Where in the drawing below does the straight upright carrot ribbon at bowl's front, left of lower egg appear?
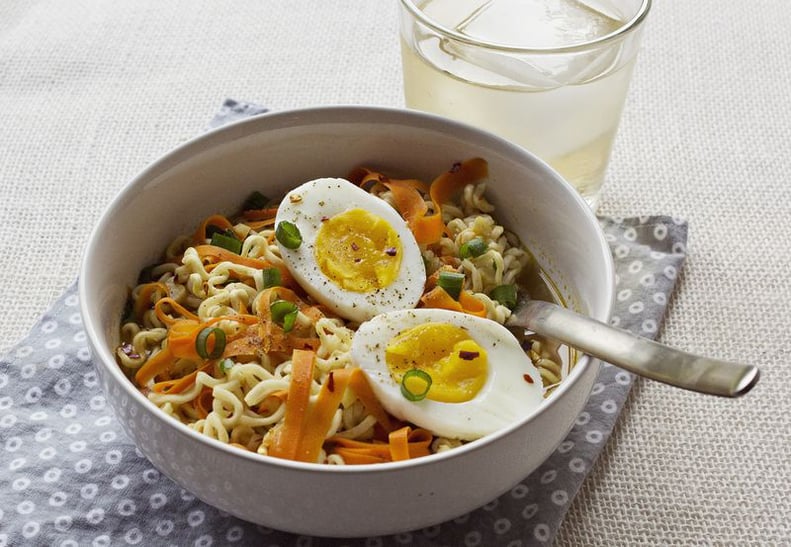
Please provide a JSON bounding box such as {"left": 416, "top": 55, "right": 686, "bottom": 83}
{"left": 269, "top": 349, "right": 316, "bottom": 460}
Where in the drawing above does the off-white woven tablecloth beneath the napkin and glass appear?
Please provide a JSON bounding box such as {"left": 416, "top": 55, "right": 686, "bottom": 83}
{"left": 0, "top": 0, "right": 791, "bottom": 545}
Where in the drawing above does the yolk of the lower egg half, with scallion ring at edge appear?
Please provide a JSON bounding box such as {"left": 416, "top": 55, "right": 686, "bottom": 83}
{"left": 385, "top": 323, "right": 489, "bottom": 403}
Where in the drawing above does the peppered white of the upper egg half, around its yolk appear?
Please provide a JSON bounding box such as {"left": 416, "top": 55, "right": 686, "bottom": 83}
{"left": 275, "top": 178, "right": 426, "bottom": 322}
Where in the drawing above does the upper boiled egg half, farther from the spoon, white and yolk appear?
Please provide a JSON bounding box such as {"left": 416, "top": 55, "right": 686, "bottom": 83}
{"left": 275, "top": 178, "right": 426, "bottom": 322}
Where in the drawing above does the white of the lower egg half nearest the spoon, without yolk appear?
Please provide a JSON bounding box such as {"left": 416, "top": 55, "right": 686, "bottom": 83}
{"left": 351, "top": 308, "right": 543, "bottom": 440}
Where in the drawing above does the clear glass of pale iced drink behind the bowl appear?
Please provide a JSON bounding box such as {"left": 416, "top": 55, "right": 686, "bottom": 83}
{"left": 400, "top": 0, "right": 651, "bottom": 210}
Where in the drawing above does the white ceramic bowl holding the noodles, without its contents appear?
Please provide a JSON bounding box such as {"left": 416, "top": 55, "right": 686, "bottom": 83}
{"left": 79, "top": 107, "right": 614, "bottom": 537}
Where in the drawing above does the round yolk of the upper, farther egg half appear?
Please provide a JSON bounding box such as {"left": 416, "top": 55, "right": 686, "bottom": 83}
{"left": 315, "top": 209, "right": 402, "bottom": 293}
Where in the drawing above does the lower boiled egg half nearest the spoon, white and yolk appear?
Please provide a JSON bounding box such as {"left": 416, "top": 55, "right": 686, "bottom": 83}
{"left": 351, "top": 308, "right": 543, "bottom": 440}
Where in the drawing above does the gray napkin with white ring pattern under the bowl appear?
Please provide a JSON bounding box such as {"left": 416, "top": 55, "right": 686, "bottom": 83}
{"left": 0, "top": 101, "right": 687, "bottom": 547}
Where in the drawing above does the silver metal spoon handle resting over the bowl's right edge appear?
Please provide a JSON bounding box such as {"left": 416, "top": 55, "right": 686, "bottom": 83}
{"left": 506, "top": 300, "right": 759, "bottom": 397}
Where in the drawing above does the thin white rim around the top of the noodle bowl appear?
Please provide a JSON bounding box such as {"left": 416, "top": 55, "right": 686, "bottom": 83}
{"left": 78, "top": 105, "right": 615, "bottom": 474}
